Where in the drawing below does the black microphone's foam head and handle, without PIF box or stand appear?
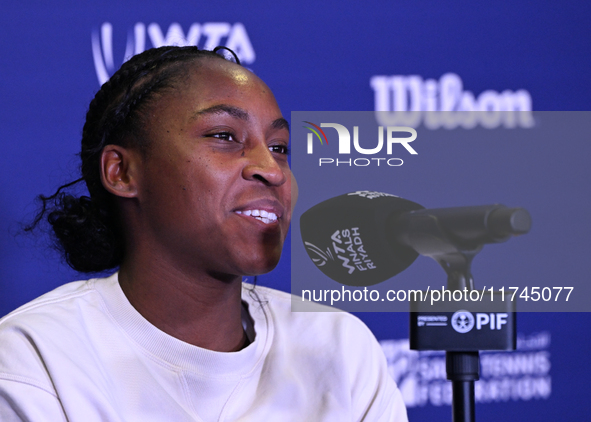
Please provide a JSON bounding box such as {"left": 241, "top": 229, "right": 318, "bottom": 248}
{"left": 300, "top": 191, "right": 531, "bottom": 286}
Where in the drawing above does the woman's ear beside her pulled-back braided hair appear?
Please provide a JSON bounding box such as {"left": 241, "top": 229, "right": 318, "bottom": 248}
{"left": 101, "top": 145, "right": 140, "bottom": 198}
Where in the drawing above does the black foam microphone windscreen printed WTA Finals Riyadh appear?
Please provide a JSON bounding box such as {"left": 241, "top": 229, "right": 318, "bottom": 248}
{"left": 300, "top": 191, "right": 423, "bottom": 286}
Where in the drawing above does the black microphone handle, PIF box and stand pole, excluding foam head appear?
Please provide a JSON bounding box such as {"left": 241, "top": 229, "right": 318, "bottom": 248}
{"left": 395, "top": 205, "right": 531, "bottom": 422}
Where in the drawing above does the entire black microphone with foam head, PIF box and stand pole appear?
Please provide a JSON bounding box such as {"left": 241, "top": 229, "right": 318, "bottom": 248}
{"left": 300, "top": 195, "right": 531, "bottom": 422}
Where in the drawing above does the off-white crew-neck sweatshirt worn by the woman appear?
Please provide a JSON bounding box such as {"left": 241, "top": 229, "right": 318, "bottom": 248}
{"left": 0, "top": 274, "right": 407, "bottom": 422}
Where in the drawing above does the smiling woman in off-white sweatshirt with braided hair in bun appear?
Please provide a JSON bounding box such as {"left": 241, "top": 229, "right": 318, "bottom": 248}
{"left": 0, "top": 47, "right": 406, "bottom": 422}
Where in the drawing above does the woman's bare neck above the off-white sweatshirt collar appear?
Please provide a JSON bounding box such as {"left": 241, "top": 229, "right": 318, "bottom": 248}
{"left": 119, "top": 259, "right": 246, "bottom": 352}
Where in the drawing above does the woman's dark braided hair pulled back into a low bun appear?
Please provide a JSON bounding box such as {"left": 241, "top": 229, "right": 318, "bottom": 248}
{"left": 25, "top": 46, "right": 240, "bottom": 273}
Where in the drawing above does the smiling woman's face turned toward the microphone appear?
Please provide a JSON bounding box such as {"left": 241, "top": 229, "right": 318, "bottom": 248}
{"left": 132, "top": 59, "right": 295, "bottom": 277}
